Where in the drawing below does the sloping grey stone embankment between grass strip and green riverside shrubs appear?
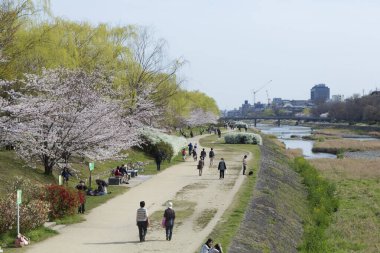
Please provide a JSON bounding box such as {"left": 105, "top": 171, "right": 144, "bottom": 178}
{"left": 229, "top": 139, "right": 307, "bottom": 253}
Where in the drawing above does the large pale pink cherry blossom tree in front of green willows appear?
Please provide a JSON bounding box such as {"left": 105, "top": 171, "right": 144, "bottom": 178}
{"left": 0, "top": 69, "right": 155, "bottom": 175}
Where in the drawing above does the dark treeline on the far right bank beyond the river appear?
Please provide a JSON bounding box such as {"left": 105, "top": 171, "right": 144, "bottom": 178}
{"left": 312, "top": 92, "right": 380, "bottom": 123}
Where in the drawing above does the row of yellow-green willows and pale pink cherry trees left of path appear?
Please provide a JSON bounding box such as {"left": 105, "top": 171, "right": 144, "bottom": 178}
{"left": 0, "top": 0, "right": 219, "bottom": 174}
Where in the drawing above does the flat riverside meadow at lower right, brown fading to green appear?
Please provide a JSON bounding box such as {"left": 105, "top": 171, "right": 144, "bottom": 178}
{"left": 311, "top": 158, "right": 380, "bottom": 253}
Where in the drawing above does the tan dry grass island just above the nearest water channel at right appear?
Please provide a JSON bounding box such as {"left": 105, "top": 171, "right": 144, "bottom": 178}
{"left": 313, "top": 139, "right": 380, "bottom": 154}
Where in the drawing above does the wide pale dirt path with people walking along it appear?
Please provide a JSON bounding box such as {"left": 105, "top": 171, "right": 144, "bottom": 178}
{"left": 26, "top": 137, "right": 250, "bottom": 253}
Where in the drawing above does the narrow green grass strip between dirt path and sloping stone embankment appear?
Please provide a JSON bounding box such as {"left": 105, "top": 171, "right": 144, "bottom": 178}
{"left": 197, "top": 135, "right": 260, "bottom": 251}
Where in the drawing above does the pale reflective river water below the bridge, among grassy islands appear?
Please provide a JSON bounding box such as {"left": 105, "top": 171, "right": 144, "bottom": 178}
{"left": 256, "top": 124, "right": 336, "bottom": 159}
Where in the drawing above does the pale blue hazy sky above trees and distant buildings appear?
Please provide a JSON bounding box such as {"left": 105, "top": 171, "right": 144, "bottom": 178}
{"left": 51, "top": 0, "right": 380, "bottom": 109}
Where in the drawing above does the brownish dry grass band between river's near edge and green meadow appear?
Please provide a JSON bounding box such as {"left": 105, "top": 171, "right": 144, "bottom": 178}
{"left": 310, "top": 158, "right": 380, "bottom": 180}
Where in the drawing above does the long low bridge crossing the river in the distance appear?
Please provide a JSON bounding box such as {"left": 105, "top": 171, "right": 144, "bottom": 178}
{"left": 219, "top": 116, "right": 331, "bottom": 126}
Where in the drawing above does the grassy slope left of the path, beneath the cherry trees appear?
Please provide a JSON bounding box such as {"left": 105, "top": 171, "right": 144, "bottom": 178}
{"left": 0, "top": 147, "right": 182, "bottom": 252}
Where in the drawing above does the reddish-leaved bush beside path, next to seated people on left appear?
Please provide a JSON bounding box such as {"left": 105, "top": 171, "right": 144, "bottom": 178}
{"left": 46, "top": 185, "right": 80, "bottom": 219}
